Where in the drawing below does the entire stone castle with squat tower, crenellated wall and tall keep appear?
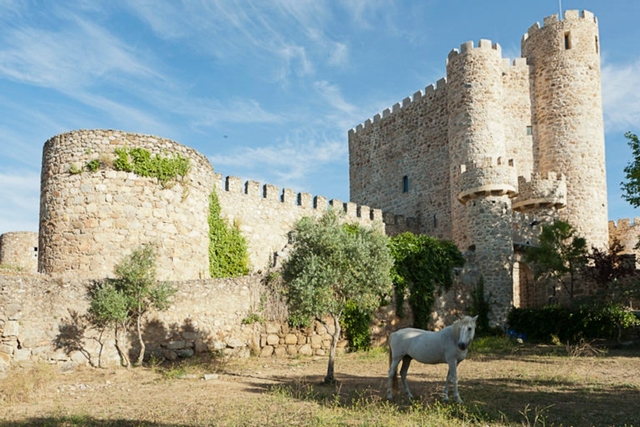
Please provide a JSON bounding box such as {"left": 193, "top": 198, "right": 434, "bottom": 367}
{"left": 0, "top": 10, "right": 636, "bottom": 330}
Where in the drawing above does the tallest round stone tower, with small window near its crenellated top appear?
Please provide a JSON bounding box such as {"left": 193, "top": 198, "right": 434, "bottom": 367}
{"left": 522, "top": 10, "right": 608, "bottom": 248}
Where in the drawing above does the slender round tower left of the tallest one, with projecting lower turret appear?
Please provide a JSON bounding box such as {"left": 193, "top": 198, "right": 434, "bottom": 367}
{"left": 447, "top": 40, "right": 517, "bottom": 324}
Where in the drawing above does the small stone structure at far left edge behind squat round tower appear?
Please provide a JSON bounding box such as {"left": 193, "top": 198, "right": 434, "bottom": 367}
{"left": 0, "top": 231, "right": 38, "bottom": 273}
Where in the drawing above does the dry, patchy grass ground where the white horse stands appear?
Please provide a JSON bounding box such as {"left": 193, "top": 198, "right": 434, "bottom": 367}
{"left": 0, "top": 347, "right": 640, "bottom": 427}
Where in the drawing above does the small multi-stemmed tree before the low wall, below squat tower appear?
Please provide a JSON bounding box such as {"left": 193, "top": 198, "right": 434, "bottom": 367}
{"left": 89, "top": 245, "right": 176, "bottom": 366}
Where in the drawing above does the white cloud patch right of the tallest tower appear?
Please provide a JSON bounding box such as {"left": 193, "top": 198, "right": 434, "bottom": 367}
{"left": 602, "top": 60, "right": 640, "bottom": 131}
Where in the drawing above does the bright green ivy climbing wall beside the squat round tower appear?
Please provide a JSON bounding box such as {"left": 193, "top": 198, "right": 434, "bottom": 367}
{"left": 209, "top": 191, "right": 249, "bottom": 278}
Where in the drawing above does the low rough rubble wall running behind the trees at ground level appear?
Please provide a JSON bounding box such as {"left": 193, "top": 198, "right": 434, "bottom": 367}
{"left": 0, "top": 274, "right": 411, "bottom": 373}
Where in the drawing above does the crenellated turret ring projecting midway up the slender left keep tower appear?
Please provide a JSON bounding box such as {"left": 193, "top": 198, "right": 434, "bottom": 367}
{"left": 453, "top": 157, "right": 518, "bottom": 204}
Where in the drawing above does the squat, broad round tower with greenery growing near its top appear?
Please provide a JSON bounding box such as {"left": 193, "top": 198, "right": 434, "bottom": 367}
{"left": 38, "top": 130, "right": 214, "bottom": 280}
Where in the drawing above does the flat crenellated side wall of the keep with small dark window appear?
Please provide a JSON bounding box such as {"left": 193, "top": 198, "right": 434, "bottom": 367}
{"left": 349, "top": 80, "right": 453, "bottom": 239}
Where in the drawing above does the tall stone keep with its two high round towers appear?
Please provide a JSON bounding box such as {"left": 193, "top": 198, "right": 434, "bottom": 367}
{"left": 349, "top": 10, "right": 608, "bottom": 322}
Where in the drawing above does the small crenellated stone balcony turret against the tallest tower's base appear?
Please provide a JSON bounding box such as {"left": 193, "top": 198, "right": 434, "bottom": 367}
{"left": 512, "top": 172, "right": 567, "bottom": 211}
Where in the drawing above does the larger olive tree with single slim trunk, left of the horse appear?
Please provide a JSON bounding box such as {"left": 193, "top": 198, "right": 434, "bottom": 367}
{"left": 282, "top": 210, "right": 393, "bottom": 382}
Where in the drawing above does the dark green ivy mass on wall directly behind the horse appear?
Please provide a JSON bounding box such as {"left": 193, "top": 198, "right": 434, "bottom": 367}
{"left": 390, "top": 232, "right": 464, "bottom": 329}
